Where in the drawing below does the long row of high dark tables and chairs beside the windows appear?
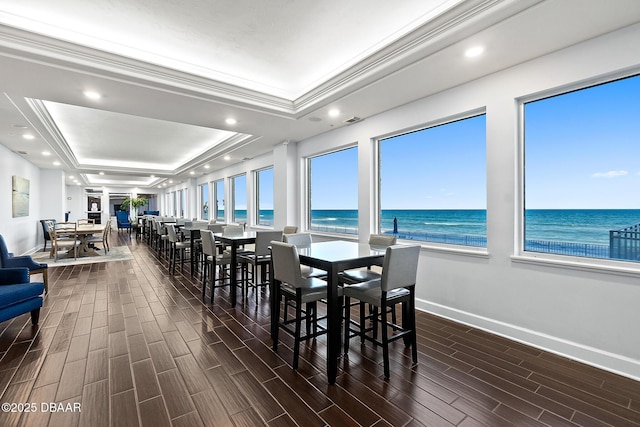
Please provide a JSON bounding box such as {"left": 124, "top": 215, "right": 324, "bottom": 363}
{"left": 135, "top": 216, "right": 420, "bottom": 384}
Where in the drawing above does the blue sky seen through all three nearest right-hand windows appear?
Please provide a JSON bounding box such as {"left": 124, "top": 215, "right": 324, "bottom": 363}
{"left": 311, "top": 76, "right": 640, "bottom": 213}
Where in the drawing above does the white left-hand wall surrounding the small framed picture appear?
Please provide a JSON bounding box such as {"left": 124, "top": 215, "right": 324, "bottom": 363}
{"left": 0, "top": 145, "right": 42, "bottom": 255}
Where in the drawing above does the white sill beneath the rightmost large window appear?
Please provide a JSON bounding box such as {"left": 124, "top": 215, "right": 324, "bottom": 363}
{"left": 511, "top": 253, "right": 640, "bottom": 277}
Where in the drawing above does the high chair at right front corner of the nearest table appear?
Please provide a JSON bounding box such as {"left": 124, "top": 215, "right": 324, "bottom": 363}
{"left": 343, "top": 245, "right": 420, "bottom": 378}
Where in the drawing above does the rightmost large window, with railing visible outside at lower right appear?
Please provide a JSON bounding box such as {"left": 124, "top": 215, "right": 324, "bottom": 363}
{"left": 523, "top": 75, "right": 640, "bottom": 262}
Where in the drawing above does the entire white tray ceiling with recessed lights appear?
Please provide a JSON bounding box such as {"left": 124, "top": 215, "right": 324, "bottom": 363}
{"left": 0, "top": 0, "right": 640, "bottom": 187}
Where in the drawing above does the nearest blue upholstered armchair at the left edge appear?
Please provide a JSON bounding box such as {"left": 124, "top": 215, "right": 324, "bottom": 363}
{"left": 0, "top": 268, "right": 44, "bottom": 325}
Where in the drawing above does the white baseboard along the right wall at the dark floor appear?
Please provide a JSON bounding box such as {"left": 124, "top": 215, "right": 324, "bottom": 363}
{"left": 416, "top": 299, "right": 640, "bottom": 381}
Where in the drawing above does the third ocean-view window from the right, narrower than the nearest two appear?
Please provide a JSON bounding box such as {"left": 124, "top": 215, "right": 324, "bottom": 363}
{"left": 308, "top": 147, "right": 358, "bottom": 234}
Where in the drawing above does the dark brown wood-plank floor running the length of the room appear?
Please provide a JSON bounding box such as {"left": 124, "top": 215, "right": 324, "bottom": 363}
{"left": 0, "top": 233, "right": 640, "bottom": 427}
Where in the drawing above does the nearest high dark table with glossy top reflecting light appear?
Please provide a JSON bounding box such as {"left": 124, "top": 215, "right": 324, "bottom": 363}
{"left": 270, "top": 240, "right": 386, "bottom": 384}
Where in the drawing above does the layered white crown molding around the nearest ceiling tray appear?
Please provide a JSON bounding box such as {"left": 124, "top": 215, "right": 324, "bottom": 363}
{"left": 0, "top": 0, "right": 542, "bottom": 119}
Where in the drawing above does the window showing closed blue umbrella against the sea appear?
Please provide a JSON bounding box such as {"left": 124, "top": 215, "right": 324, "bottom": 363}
{"left": 378, "top": 114, "right": 487, "bottom": 247}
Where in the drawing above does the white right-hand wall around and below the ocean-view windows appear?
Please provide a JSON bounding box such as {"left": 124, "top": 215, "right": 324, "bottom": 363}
{"left": 298, "top": 24, "right": 640, "bottom": 379}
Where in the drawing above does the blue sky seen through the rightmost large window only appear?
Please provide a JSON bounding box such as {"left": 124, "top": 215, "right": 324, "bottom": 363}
{"left": 525, "top": 76, "right": 640, "bottom": 209}
